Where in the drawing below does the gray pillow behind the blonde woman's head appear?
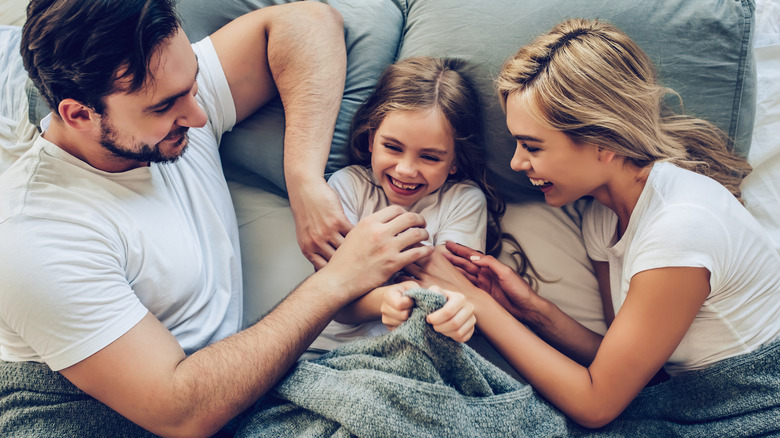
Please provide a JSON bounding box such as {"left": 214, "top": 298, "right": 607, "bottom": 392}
{"left": 399, "top": 0, "right": 756, "bottom": 201}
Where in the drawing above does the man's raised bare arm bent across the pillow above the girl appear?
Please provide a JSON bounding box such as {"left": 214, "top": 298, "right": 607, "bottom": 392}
{"left": 211, "top": 2, "right": 352, "bottom": 269}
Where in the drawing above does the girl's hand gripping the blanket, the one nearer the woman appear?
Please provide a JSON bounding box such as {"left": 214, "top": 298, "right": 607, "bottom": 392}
{"left": 425, "top": 286, "right": 477, "bottom": 342}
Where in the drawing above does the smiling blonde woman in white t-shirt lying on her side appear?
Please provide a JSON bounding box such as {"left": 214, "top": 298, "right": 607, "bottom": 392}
{"left": 402, "top": 19, "right": 780, "bottom": 436}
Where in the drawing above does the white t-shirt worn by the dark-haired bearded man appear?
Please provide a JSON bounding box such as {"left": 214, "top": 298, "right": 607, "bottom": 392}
{"left": 0, "top": 39, "right": 242, "bottom": 370}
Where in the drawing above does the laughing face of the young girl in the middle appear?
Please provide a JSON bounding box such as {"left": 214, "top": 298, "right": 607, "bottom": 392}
{"left": 368, "top": 109, "right": 456, "bottom": 207}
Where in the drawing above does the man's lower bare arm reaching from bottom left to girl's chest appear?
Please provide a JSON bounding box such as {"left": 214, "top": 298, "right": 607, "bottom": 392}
{"left": 61, "top": 206, "right": 431, "bottom": 436}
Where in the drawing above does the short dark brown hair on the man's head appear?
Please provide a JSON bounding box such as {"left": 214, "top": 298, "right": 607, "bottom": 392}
{"left": 21, "top": 0, "right": 179, "bottom": 114}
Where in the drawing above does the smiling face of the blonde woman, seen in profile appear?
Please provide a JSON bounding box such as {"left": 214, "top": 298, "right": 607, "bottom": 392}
{"left": 506, "top": 93, "right": 605, "bottom": 207}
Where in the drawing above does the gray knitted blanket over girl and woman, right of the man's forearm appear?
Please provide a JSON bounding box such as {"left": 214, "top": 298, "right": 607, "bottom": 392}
{"left": 237, "top": 290, "right": 780, "bottom": 437}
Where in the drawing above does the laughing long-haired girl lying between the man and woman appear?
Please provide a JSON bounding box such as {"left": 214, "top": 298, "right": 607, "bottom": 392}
{"left": 310, "top": 57, "right": 520, "bottom": 351}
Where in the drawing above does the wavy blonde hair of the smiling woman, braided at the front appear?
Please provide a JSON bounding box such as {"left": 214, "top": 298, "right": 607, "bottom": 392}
{"left": 497, "top": 19, "right": 751, "bottom": 199}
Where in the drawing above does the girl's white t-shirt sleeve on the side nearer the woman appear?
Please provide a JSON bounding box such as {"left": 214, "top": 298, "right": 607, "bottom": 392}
{"left": 434, "top": 184, "right": 487, "bottom": 252}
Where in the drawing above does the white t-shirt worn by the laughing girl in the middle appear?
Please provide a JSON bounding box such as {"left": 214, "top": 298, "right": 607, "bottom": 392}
{"left": 306, "top": 165, "right": 487, "bottom": 352}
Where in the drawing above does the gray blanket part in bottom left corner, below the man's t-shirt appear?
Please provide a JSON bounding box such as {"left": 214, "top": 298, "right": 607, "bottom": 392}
{"left": 0, "top": 362, "right": 155, "bottom": 438}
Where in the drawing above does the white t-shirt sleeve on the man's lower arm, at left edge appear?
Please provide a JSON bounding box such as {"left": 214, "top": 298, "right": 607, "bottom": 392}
{"left": 0, "top": 216, "right": 147, "bottom": 371}
